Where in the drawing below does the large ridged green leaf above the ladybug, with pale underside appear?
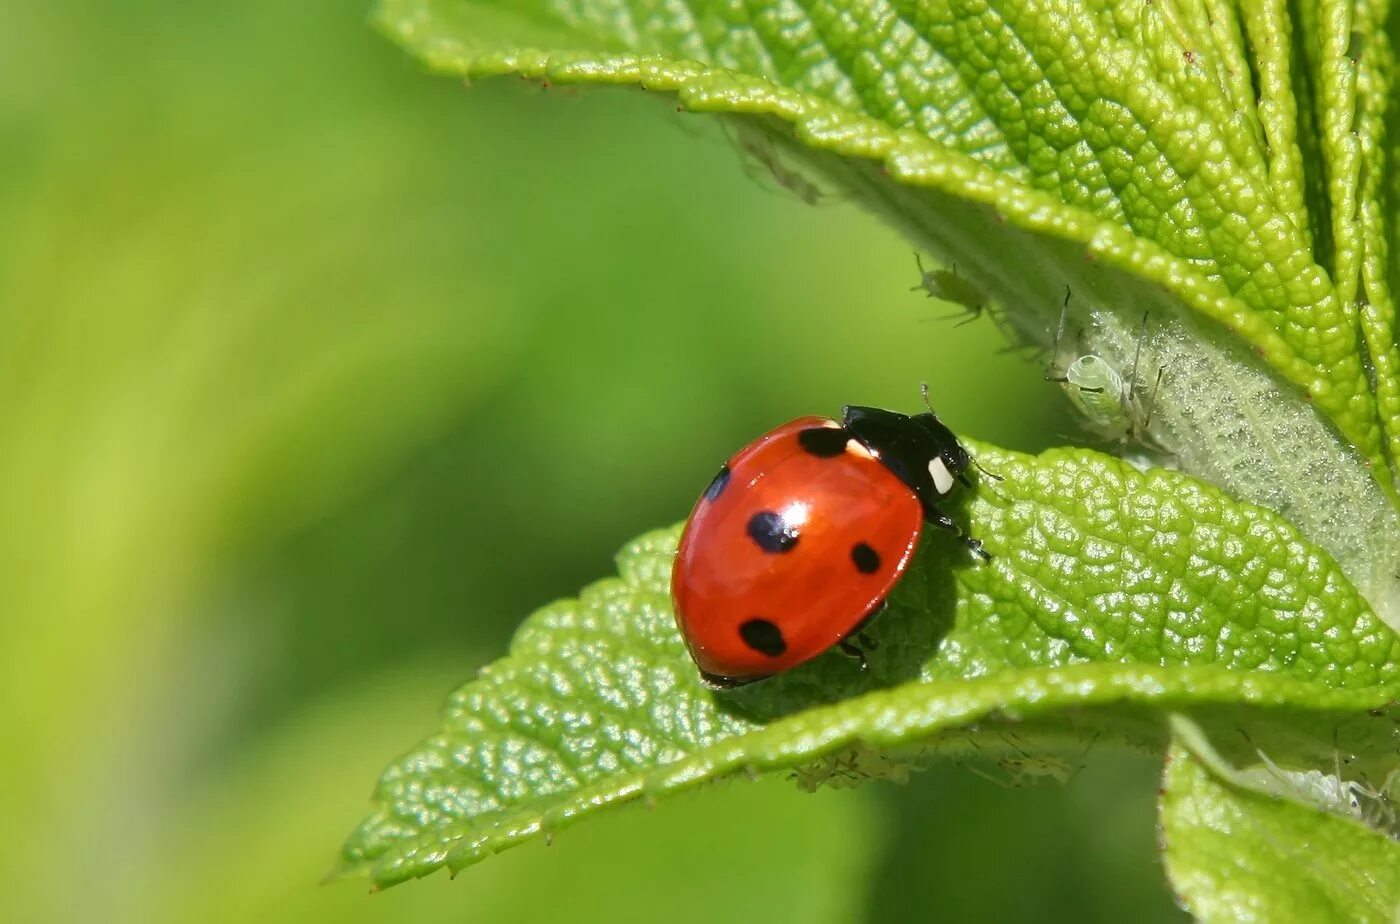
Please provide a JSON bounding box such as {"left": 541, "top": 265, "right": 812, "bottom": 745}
{"left": 378, "top": 0, "right": 1400, "bottom": 627}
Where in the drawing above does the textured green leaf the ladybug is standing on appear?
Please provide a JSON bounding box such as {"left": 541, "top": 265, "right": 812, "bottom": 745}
{"left": 344, "top": 445, "right": 1400, "bottom": 885}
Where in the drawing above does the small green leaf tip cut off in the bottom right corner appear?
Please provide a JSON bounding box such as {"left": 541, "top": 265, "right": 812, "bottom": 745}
{"left": 1161, "top": 720, "right": 1400, "bottom": 924}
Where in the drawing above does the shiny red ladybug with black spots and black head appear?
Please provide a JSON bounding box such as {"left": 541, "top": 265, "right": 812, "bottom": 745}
{"left": 671, "top": 396, "right": 995, "bottom": 689}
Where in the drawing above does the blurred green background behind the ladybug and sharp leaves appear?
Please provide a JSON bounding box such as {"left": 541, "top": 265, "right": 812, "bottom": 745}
{"left": 0, "top": 0, "right": 1177, "bottom": 924}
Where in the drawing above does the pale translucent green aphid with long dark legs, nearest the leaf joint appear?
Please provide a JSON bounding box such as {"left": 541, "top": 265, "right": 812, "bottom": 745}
{"left": 1046, "top": 287, "right": 1166, "bottom": 442}
